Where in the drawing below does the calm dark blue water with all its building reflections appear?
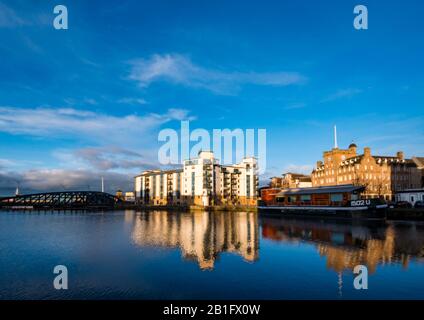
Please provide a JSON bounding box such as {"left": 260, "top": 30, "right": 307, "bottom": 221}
{"left": 0, "top": 210, "right": 424, "bottom": 299}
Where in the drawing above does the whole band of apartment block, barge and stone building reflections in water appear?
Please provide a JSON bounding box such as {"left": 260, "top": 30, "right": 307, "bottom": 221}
{"left": 129, "top": 211, "right": 424, "bottom": 274}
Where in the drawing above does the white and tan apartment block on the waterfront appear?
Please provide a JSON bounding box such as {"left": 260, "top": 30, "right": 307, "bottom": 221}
{"left": 135, "top": 151, "right": 258, "bottom": 207}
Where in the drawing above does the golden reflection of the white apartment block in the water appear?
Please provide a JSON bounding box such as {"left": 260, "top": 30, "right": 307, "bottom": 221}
{"left": 132, "top": 211, "right": 259, "bottom": 269}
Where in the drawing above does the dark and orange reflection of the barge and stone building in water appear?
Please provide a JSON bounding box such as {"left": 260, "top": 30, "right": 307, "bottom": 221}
{"left": 261, "top": 218, "right": 424, "bottom": 274}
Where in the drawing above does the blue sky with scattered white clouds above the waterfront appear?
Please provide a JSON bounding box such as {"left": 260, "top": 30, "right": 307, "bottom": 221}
{"left": 0, "top": 0, "right": 424, "bottom": 193}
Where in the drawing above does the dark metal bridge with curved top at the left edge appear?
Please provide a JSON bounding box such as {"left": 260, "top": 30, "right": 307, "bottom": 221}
{"left": 0, "top": 191, "right": 121, "bottom": 209}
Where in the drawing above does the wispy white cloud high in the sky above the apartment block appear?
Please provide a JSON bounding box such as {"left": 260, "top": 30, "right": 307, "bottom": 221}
{"left": 129, "top": 54, "right": 306, "bottom": 95}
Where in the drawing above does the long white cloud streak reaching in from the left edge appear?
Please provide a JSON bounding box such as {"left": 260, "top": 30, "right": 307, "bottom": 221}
{"left": 0, "top": 107, "right": 193, "bottom": 141}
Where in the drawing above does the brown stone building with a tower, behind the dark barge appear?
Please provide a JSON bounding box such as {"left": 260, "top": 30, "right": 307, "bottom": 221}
{"left": 312, "top": 143, "right": 424, "bottom": 200}
